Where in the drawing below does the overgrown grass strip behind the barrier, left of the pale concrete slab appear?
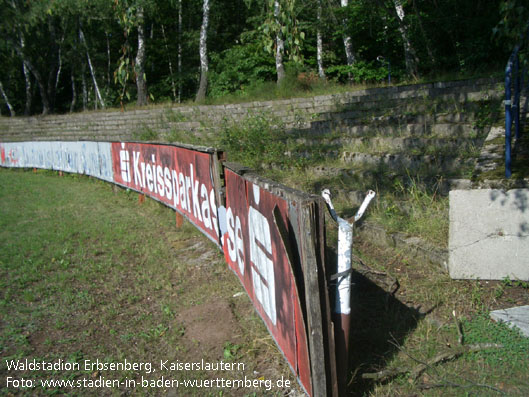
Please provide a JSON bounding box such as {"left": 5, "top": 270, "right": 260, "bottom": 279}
{"left": 263, "top": 161, "right": 449, "bottom": 247}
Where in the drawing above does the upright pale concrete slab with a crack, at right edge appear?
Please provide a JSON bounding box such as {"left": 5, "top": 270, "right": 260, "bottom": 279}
{"left": 448, "top": 189, "right": 529, "bottom": 280}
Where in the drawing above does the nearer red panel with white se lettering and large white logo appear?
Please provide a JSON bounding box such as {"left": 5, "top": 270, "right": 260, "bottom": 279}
{"left": 221, "top": 169, "right": 311, "bottom": 395}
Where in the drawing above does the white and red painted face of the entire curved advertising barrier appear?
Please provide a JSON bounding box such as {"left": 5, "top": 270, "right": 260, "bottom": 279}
{"left": 0, "top": 141, "right": 325, "bottom": 395}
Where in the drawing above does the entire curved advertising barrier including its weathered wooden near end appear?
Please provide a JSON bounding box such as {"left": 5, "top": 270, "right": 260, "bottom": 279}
{"left": 0, "top": 141, "right": 338, "bottom": 396}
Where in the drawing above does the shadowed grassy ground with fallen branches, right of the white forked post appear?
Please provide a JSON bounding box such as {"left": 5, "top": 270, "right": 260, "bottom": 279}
{"left": 349, "top": 239, "right": 529, "bottom": 396}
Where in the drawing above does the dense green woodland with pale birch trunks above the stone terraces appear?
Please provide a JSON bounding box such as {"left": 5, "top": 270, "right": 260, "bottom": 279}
{"left": 0, "top": 0, "right": 529, "bottom": 115}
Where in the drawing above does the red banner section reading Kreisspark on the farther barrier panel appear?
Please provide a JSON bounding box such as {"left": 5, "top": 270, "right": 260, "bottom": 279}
{"left": 112, "top": 142, "right": 219, "bottom": 245}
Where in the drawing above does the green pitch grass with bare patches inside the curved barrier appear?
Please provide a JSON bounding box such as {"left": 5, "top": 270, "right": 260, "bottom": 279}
{"left": 0, "top": 169, "right": 296, "bottom": 396}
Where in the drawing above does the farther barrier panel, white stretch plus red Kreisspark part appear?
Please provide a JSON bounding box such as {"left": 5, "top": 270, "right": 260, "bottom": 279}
{"left": 0, "top": 141, "right": 220, "bottom": 245}
